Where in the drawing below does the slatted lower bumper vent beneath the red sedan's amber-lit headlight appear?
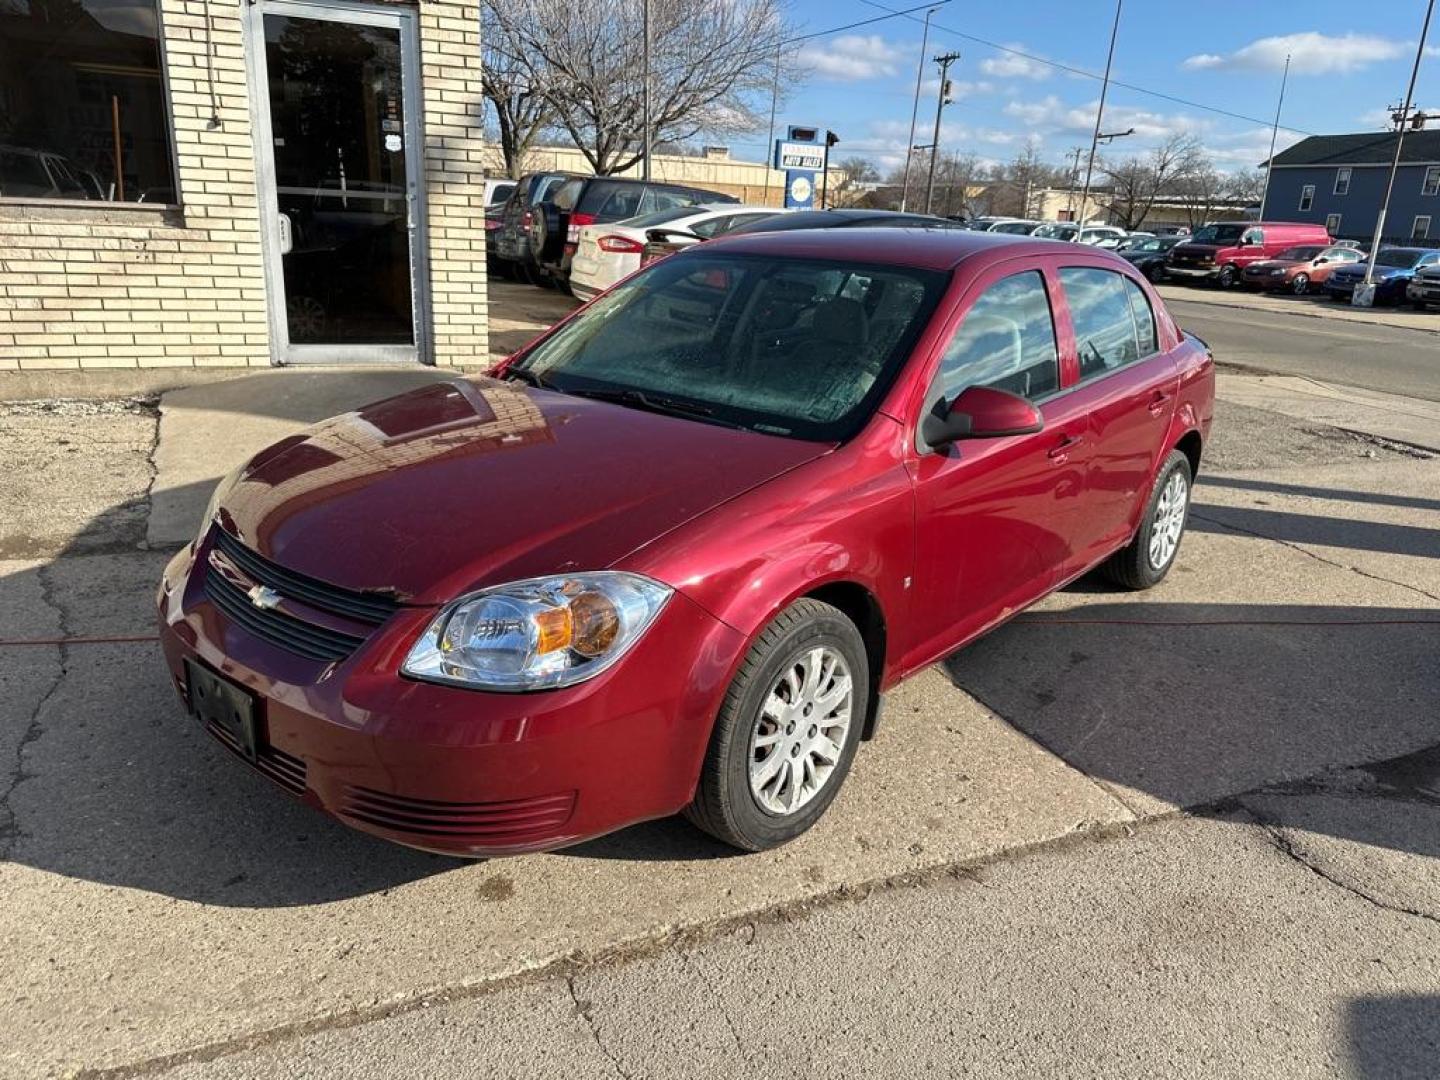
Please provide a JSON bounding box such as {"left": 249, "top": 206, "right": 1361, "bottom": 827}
{"left": 340, "top": 788, "right": 575, "bottom": 845}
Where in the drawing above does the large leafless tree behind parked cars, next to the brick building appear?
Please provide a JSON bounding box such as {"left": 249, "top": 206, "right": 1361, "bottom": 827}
{"left": 491, "top": 0, "right": 789, "bottom": 176}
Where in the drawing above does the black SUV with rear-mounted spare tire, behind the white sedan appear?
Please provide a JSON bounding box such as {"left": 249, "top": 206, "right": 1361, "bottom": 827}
{"left": 530, "top": 176, "right": 740, "bottom": 291}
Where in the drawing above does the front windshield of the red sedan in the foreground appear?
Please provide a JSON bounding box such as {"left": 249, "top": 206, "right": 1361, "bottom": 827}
{"left": 514, "top": 252, "right": 946, "bottom": 442}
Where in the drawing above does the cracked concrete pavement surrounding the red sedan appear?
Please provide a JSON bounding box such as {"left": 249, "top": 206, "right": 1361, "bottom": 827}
{"left": 0, "top": 289, "right": 1440, "bottom": 1077}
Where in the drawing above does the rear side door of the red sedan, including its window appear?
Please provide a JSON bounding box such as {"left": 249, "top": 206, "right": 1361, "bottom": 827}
{"left": 1057, "top": 258, "right": 1179, "bottom": 577}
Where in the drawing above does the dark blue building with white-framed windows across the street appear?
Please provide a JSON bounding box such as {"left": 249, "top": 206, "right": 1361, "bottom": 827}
{"left": 1260, "top": 131, "right": 1440, "bottom": 246}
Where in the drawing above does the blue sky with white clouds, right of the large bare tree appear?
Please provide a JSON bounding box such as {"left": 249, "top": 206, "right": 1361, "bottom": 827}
{"left": 732, "top": 0, "right": 1440, "bottom": 170}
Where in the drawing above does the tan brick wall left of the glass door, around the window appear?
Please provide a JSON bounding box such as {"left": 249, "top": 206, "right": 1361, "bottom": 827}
{"left": 0, "top": 0, "right": 269, "bottom": 370}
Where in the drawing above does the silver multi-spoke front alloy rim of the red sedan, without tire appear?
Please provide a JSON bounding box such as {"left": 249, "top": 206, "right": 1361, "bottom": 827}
{"left": 750, "top": 645, "right": 854, "bottom": 816}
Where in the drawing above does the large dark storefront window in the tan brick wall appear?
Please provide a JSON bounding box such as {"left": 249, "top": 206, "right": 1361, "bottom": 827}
{"left": 0, "top": 0, "right": 177, "bottom": 203}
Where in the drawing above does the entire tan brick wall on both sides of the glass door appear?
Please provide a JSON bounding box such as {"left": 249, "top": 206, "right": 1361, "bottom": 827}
{"left": 0, "top": 0, "right": 488, "bottom": 370}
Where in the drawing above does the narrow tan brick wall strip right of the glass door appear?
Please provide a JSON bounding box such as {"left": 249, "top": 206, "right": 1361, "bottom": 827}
{"left": 420, "top": 0, "right": 488, "bottom": 366}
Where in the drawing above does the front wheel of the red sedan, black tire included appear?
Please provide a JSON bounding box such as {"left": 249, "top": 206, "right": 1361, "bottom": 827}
{"left": 684, "top": 599, "right": 870, "bottom": 851}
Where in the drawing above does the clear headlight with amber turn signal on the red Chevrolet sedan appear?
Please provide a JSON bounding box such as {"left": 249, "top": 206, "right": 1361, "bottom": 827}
{"left": 400, "top": 570, "right": 671, "bottom": 690}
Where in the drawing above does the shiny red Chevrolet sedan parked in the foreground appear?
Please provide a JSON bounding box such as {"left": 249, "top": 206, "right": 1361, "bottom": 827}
{"left": 158, "top": 229, "right": 1214, "bottom": 855}
